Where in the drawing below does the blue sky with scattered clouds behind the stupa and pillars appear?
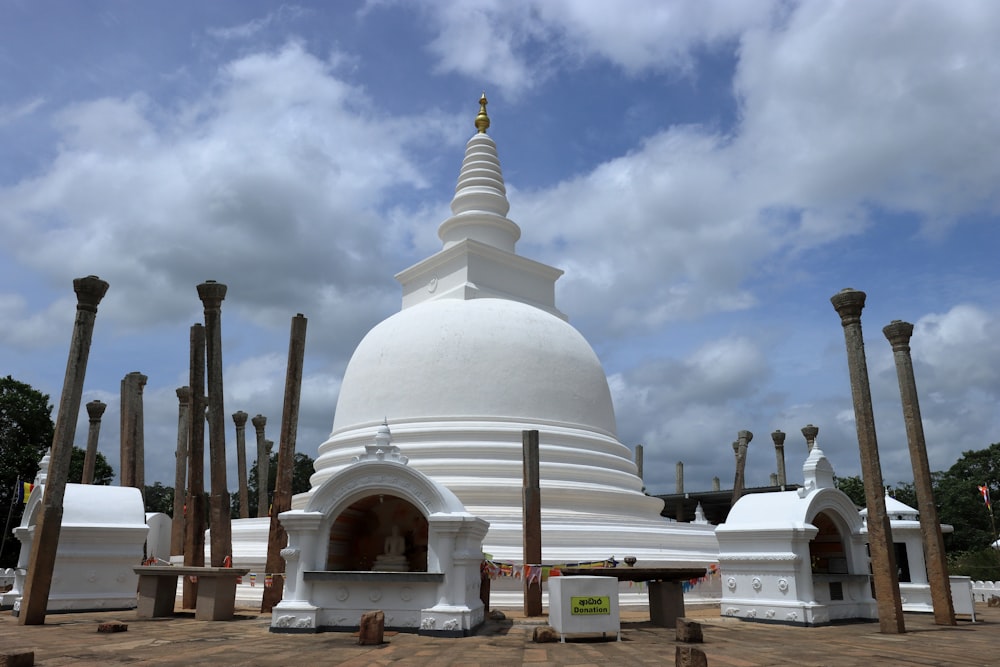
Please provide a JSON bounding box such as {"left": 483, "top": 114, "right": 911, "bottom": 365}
{"left": 0, "top": 0, "right": 1000, "bottom": 500}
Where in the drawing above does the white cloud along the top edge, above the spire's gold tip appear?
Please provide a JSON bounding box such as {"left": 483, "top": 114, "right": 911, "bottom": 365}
{"left": 410, "top": 0, "right": 777, "bottom": 97}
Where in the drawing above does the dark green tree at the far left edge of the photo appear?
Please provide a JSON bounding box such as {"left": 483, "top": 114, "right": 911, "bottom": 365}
{"left": 0, "top": 375, "right": 55, "bottom": 567}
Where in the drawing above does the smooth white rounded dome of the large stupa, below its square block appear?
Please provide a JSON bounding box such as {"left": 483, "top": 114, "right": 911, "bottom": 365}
{"left": 333, "top": 298, "right": 615, "bottom": 436}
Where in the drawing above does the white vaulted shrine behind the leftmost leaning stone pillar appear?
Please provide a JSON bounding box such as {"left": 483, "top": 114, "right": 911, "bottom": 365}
{"left": 0, "top": 454, "right": 148, "bottom": 616}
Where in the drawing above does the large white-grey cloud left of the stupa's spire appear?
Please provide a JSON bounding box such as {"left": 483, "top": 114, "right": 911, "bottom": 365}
{"left": 0, "top": 43, "right": 445, "bottom": 344}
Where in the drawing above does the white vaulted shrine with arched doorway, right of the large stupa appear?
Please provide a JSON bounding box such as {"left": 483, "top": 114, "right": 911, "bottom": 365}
{"left": 715, "top": 446, "right": 878, "bottom": 626}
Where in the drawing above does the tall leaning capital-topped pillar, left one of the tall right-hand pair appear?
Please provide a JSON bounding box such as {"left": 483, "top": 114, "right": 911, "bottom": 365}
{"left": 828, "top": 289, "right": 906, "bottom": 634}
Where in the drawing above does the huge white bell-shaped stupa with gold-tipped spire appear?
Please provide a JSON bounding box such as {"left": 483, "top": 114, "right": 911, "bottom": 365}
{"left": 306, "top": 95, "right": 718, "bottom": 564}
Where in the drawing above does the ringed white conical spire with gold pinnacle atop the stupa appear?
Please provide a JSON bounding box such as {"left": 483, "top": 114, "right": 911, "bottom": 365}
{"left": 438, "top": 93, "right": 521, "bottom": 253}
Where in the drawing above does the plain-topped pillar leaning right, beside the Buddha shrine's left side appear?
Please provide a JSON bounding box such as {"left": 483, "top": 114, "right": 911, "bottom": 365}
{"left": 260, "top": 313, "right": 308, "bottom": 613}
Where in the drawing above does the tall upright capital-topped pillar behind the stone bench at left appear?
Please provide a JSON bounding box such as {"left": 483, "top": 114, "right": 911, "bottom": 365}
{"left": 198, "top": 280, "right": 233, "bottom": 567}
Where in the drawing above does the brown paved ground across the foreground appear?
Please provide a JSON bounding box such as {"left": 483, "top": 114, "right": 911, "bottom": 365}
{"left": 0, "top": 604, "right": 1000, "bottom": 667}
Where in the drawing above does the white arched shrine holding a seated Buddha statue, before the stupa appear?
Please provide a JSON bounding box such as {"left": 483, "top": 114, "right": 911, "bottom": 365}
{"left": 271, "top": 424, "right": 489, "bottom": 637}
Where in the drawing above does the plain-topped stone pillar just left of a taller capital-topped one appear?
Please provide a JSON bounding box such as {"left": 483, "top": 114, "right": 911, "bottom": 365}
{"left": 183, "top": 324, "right": 205, "bottom": 609}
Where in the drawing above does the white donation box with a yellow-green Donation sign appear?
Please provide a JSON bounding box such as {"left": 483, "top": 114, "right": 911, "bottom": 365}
{"left": 548, "top": 577, "right": 621, "bottom": 642}
